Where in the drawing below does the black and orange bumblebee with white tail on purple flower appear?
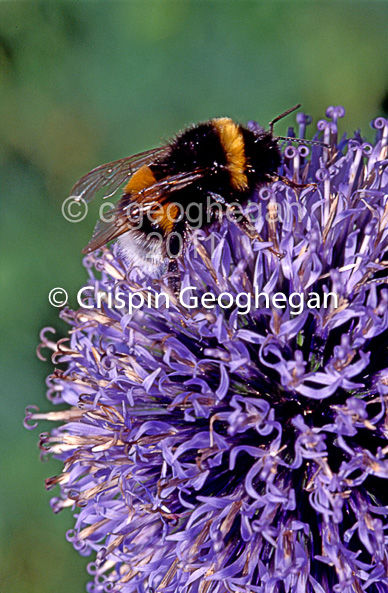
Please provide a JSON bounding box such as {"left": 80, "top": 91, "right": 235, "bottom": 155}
{"left": 72, "top": 105, "right": 321, "bottom": 291}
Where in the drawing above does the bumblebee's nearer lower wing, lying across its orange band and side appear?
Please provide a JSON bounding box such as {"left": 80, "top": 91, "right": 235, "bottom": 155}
{"left": 82, "top": 169, "right": 205, "bottom": 253}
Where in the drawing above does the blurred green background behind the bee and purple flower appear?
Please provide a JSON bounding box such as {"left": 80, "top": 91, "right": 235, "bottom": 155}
{"left": 0, "top": 0, "right": 388, "bottom": 593}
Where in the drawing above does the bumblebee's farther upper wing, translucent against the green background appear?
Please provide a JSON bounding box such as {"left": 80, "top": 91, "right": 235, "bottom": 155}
{"left": 70, "top": 145, "right": 168, "bottom": 202}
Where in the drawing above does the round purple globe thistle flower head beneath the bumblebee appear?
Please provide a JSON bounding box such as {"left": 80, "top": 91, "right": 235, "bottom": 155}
{"left": 26, "top": 107, "right": 388, "bottom": 593}
